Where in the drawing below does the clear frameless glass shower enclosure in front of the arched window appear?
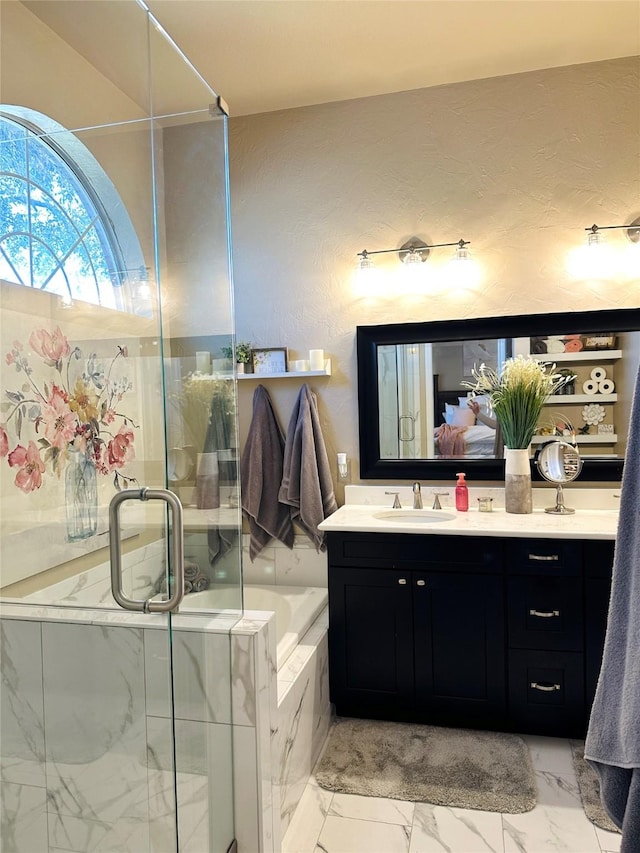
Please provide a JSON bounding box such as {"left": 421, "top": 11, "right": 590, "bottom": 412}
{"left": 0, "top": 0, "right": 241, "bottom": 853}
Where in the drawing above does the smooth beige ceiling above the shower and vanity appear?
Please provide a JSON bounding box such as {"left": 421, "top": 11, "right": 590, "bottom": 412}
{"left": 20, "top": 0, "right": 640, "bottom": 116}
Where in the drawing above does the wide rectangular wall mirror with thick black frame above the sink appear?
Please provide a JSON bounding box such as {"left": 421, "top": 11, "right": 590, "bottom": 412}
{"left": 357, "top": 308, "right": 640, "bottom": 482}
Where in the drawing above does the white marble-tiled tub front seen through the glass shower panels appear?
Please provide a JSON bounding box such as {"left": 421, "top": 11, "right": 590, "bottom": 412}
{"left": 0, "top": 610, "right": 245, "bottom": 853}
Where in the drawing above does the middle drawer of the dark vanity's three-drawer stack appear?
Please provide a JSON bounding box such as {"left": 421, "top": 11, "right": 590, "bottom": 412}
{"left": 507, "top": 575, "right": 584, "bottom": 652}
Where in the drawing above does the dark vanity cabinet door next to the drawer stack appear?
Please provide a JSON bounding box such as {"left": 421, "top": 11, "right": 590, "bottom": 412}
{"left": 413, "top": 572, "right": 505, "bottom": 728}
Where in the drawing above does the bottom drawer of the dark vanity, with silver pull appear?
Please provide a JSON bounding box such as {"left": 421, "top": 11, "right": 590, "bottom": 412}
{"left": 509, "top": 649, "right": 586, "bottom": 737}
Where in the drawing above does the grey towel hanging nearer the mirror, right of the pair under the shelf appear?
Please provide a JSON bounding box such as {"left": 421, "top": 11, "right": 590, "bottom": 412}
{"left": 280, "top": 383, "right": 338, "bottom": 551}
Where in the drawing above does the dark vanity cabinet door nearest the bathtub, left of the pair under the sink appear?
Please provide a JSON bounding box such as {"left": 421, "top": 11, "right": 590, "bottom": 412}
{"left": 329, "top": 566, "right": 413, "bottom": 720}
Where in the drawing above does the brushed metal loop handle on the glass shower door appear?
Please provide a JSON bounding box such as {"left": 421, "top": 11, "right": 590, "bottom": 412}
{"left": 109, "top": 489, "right": 184, "bottom": 613}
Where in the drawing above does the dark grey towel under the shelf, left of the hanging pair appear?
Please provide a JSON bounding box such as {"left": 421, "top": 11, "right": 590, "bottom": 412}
{"left": 240, "top": 385, "right": 293, "bottom": 562}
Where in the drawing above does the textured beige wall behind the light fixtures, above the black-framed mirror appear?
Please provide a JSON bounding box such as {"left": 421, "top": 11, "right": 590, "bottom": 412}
{"left": 230, "top": 57, "right": 640, "bottom": 490}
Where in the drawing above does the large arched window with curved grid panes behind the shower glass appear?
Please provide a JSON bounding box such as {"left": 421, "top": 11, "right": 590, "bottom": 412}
{"left": 0, "top": 106, "right": 149, "bottom": 314}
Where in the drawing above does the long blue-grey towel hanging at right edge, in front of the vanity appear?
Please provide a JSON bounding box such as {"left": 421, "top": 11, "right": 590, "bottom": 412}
{"left": 585, "top": 360, "right": 640, "bottom": 853}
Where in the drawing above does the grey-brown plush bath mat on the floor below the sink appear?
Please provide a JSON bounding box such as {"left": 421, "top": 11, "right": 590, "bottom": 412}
{"left": 314, "top": 717, "right": 536, "bottom": 814}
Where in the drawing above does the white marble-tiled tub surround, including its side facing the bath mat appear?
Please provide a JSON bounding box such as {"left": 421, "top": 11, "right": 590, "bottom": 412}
{"left": 0, "top": 572, "right": 330, "bottom": 853}
